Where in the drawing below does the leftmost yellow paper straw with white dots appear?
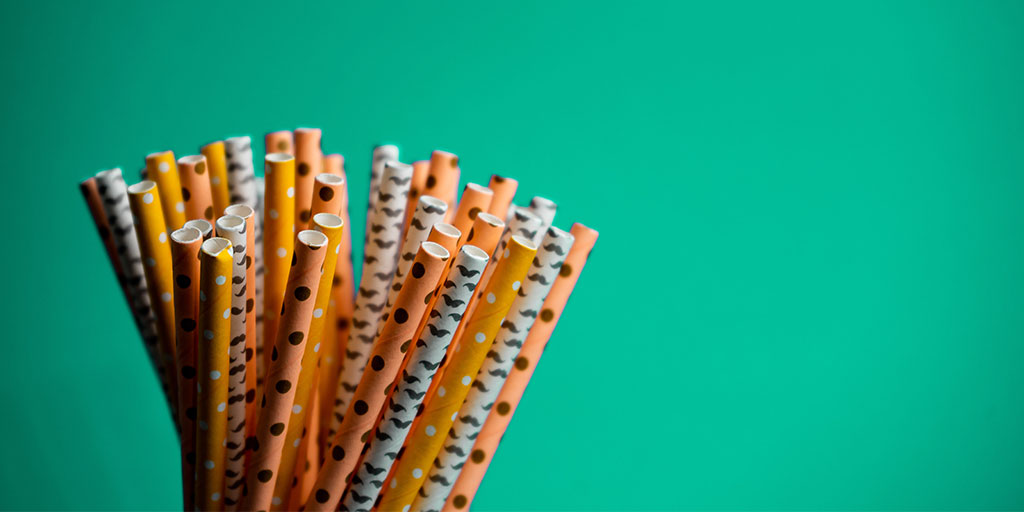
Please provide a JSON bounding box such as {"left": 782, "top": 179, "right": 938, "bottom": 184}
{"left": 128, "top": 180, "right": 178, "bottom": 419}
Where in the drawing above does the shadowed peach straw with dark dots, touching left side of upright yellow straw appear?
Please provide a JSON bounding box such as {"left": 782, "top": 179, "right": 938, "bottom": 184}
{"left": 171, "top": 227, "right": 203, "bottom": 510}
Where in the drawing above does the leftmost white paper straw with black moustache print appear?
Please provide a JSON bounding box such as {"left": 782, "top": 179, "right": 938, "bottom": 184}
{"left": 95, "top": 169, "right": 174, "bottom": 404}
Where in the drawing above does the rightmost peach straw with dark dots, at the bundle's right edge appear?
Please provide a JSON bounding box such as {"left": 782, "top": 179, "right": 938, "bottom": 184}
{"left": 444, "top": 223, "right": 598, "bottom": 512}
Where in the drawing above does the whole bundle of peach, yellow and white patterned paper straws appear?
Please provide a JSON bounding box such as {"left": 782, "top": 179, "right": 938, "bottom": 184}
{"left": 81, "top": 128, "right": 597, "bottom": 511}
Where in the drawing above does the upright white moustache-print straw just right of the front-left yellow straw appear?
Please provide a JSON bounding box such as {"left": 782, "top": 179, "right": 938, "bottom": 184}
{"left": 216, "top": 214, "right": 248, "bottom": 509}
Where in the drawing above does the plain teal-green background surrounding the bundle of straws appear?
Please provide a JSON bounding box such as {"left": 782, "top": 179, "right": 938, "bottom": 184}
{"left": 0, "top": 1, "right": 1024, "bottom": 510}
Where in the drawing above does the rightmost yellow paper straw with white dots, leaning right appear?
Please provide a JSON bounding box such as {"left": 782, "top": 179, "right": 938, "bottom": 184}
{"left": 378, "top": 237, "right": 537, "bottom": 510}
